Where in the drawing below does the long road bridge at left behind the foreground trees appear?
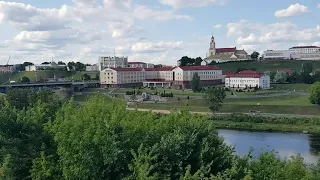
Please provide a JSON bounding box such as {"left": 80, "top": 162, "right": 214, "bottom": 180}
{"left": 0, "top": 81, "right": 100, "bottom": 93}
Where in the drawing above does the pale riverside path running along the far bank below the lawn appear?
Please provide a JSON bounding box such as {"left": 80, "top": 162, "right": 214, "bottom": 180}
{"left": 127, "top": 108, "right": 320, "bottom": 118}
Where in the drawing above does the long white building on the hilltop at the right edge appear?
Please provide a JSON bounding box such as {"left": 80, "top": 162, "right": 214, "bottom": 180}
{"left": 263, "top": 46, "right": 320, "bottom": 60}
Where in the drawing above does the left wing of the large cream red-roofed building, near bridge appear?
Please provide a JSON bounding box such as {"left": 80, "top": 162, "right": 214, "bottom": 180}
{"left": 100, "top": 68, "right": 145, "bottom": 88}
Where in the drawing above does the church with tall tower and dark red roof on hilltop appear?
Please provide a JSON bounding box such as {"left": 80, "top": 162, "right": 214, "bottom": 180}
{"left": 202, "top": 36, "right": 250, "bottom": 65}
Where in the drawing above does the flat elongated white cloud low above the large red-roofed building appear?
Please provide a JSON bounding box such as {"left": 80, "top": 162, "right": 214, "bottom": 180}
{"left": 131, "top": 41, "right": 182, "bottom": 53}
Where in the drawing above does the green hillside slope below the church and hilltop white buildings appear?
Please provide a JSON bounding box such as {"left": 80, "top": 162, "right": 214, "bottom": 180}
{"left": 216, "top": 60, "right": 320, "bottom": 73}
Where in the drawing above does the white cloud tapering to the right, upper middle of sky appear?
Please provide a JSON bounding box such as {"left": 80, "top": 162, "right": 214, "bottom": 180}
{"left": 134, "top": 5, "right": 192, "bottom": 21}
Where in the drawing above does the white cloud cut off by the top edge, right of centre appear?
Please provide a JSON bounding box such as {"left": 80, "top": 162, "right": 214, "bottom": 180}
{"left": 160, "top": 0, "right": 225, "bottom": 9}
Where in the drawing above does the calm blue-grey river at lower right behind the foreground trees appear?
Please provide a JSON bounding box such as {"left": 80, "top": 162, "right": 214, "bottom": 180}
{"left": 218, "top": 129, "right": 320, "bottom": 164}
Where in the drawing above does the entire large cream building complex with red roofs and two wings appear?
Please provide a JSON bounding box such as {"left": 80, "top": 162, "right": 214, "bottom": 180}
{"left": 100, "top": 66, "right": 222, "bottom": 89}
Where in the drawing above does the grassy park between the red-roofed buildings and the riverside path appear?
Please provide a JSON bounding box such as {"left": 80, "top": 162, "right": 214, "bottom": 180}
{"left": 75, "top": 84, "right": 320, "bottom": 115}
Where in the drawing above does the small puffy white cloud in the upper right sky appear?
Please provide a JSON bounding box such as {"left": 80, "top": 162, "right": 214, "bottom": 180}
{"left": 274, "top": 3, "right": 309, "bottom": 17}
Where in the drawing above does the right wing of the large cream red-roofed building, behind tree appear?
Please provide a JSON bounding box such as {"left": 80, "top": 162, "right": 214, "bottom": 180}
{"left": 172, "top": 66, "right": 222, "bottom": 89}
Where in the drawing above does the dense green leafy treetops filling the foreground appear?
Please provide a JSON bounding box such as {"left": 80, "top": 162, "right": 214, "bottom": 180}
{"left": 0, "top": 89, "right": 320, "bottom": 180}
